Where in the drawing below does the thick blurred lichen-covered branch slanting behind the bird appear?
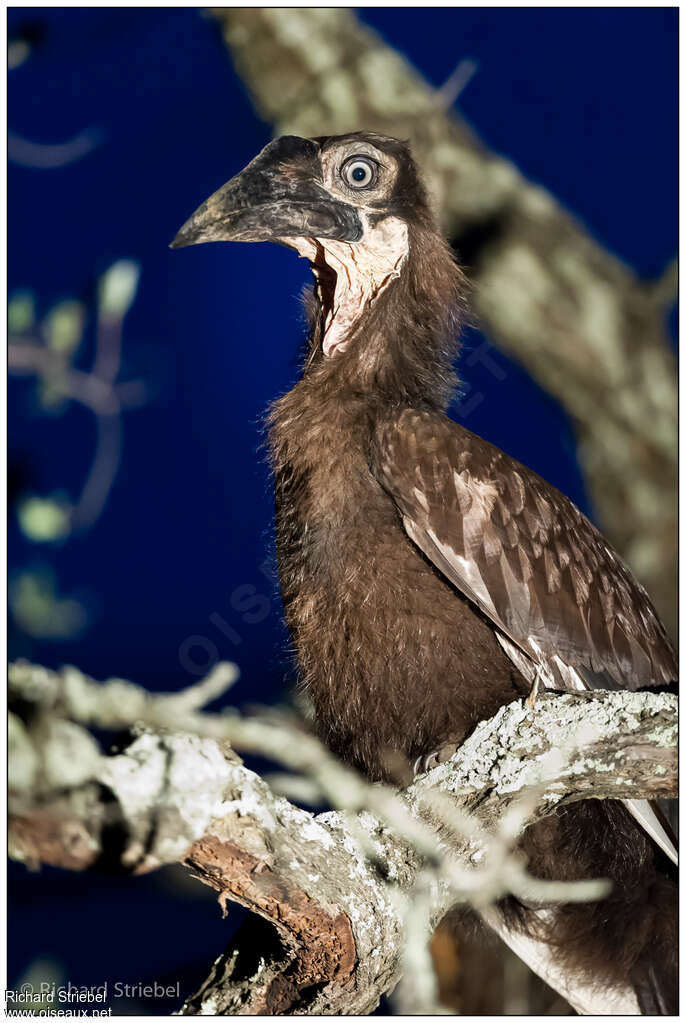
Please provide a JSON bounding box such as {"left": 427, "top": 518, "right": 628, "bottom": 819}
{"left": 213, "top": 7, "right": 677, "bottom": 634}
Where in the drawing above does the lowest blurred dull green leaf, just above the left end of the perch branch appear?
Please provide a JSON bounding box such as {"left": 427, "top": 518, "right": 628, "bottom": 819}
{"left": 9, "top": 570, "right": 88, "bottom": 639}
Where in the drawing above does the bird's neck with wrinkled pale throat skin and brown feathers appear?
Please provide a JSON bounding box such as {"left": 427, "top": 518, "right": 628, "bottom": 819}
{"left": 292, "top": 224, "right": 466, "bottom": 409}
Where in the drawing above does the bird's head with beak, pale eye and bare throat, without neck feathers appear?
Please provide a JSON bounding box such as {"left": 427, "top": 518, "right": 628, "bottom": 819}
{"left": 172, "top": 132, "right": 449, "bottom": 357}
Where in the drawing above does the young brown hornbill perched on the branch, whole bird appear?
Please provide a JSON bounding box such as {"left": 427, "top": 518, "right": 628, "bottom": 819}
{"left": 173, "top": 132, "right": 677, "bottom": 1014}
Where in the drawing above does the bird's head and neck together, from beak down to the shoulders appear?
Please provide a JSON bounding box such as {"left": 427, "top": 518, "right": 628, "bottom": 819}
{"left": 172, "top": 132, "right": 465, "bottom": 406}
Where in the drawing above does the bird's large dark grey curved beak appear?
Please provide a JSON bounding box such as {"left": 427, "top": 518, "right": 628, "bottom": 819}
{"left": 171, "top": 135, "right": 363, "bottom": 249}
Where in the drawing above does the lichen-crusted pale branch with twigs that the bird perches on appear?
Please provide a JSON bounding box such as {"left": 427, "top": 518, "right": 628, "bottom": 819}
{"left": 9, "top": 663, "right": 677, "bottom": 1015}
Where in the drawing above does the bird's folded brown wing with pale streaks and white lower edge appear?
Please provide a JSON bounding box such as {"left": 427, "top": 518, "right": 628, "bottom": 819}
{"left": 371, "top": 410, "right": 677, "bottom": 862}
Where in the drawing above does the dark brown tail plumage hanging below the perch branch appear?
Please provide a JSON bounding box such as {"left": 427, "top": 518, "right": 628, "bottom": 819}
{"left": 498, "top": 800, "right": 678, "bottom": 1015}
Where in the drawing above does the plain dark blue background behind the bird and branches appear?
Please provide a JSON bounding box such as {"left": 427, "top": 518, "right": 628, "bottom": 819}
{"left": 8, "top": 8, "right": 678, "bottom": 1010}
